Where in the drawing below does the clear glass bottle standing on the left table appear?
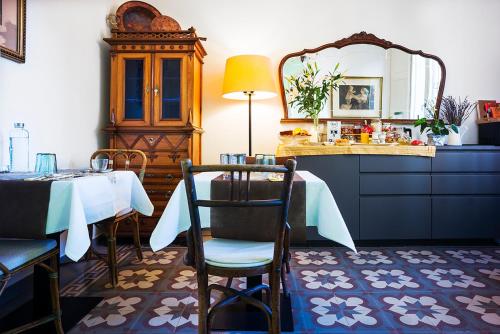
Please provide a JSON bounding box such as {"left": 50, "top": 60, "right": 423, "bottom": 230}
{"left": 9, "top": 123, "right": 30, "bottom": 172}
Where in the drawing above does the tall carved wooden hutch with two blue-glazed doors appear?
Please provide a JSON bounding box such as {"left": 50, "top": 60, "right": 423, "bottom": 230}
{"left": 104, "top": 1, "right": 206, "bottom": 236}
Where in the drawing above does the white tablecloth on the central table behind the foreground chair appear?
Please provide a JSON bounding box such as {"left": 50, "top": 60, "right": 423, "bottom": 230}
{"left": 150, "top": 171, "right": 356, "bottom": 251}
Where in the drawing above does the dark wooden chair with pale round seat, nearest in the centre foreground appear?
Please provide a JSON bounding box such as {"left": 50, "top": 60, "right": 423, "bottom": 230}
{"left": 181, "top": 160, "right": 296, "bottom": 333}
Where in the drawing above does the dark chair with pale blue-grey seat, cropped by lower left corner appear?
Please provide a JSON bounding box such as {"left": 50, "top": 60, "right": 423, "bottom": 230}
{"left": 0, "top": 239, "right": 64, "bottom": 334}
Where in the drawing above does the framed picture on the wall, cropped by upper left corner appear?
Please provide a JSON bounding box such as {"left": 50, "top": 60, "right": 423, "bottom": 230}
{"left": 0, "top": 0, "right": 26, "bottom": 63}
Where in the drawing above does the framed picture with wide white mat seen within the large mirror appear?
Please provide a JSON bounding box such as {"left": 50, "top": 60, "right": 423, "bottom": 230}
{"left": 331, "top": 77, "right": 382, "bottom": 118}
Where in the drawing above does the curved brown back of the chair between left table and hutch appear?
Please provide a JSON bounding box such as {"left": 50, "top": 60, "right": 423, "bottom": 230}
{"left": 90, "top": 149, "right": 148, "bottom": 182}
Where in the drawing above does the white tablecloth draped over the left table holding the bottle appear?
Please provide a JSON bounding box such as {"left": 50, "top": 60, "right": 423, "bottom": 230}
{"left": 46, "top": 171, "right": 154, "bottom": 261}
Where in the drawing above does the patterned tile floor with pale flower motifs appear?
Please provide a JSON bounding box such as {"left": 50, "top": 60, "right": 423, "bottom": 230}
{"left": 62, "top": 246, "right": 500, "bottom": 334}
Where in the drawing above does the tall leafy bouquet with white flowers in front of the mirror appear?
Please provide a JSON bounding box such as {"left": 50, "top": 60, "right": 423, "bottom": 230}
{"left": 285, "top": 62, "right": 344, "bottom": 141}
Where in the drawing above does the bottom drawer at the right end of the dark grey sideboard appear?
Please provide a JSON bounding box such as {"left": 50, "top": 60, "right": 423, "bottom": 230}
{"left": 432, "top": 196, "right": 500, "bottom": 239}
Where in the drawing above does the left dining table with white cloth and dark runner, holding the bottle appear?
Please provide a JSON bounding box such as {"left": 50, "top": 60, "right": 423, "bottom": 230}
{"left": 0, "top": 170, "right": 154, "bottom": 331}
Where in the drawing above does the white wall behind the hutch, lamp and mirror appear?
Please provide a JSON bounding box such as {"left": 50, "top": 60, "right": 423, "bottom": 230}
{"left": 0, "top": 0, "right": 500, "bottom": 167}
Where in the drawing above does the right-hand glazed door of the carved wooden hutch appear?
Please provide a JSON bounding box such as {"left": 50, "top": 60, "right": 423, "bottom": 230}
{"left": 154, "top": 55, "right": 186, "bottom": 125}
